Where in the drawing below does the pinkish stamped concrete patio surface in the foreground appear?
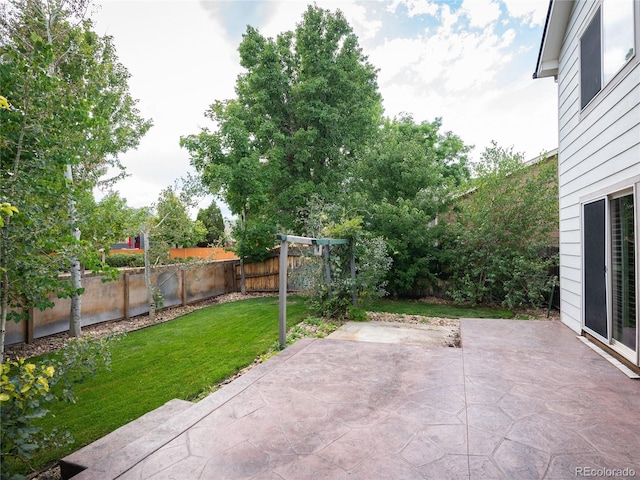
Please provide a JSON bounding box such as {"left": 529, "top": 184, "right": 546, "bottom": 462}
{"left": 65, "top": 319, "right": 640, "bottom": 480}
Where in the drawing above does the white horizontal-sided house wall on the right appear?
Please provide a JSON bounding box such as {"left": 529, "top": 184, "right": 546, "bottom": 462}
{"left": 558, "top": 1, "right": 640, "bottom": 332}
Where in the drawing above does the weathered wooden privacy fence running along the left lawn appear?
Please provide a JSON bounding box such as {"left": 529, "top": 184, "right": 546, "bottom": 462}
{"left": 5, "top": 253, "right": 302, "bottom": 345}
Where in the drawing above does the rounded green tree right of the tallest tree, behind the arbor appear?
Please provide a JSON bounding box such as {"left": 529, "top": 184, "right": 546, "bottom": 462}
{"left": 353, "top": 115, "right": 469, "bottom": 295}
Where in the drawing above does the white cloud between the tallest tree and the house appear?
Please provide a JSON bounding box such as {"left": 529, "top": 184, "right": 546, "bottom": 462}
{"left": 370, "top": 3, "right": 557, "bottom": 163}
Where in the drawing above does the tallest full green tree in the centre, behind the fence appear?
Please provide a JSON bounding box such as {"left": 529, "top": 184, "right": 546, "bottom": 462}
{"left": 182, "top": 6, "right": 382, "bottom": 231}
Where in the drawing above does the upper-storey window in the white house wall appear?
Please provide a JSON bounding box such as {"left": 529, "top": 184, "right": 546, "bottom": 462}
{"left": 580, "top": 0, "right": 635, "bottom": 108}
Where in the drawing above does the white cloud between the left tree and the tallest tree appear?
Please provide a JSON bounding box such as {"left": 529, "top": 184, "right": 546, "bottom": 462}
{"left": 93, "top": 1, "right": 240, "bottom": 207}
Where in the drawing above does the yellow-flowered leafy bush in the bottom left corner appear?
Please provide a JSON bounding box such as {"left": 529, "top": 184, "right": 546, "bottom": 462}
{"left": 0, "top": 336, "right": 120, "bottom": 480}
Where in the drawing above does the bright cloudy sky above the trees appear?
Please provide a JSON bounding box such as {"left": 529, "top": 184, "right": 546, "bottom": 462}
{"left": 91, "top": 0, "right": 558, "bottom": 218}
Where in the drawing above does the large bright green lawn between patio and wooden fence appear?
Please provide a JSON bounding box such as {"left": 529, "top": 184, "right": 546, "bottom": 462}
{"left": 28, "top": 297, "right": 307, "bottom": 472}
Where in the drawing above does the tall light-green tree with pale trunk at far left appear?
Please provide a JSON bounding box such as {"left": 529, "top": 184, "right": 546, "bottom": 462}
{"left": 0, "top": 0, "right": 151, "bottom": 346}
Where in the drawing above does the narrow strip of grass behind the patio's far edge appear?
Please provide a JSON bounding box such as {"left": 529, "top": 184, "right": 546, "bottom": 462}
{"left": 362, "top": 299, "right": 514, "bottom": 318}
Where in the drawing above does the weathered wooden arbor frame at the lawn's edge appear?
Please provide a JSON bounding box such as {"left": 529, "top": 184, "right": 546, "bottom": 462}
{"left": 277, "top": 234, "right": 357, "bottom": 348}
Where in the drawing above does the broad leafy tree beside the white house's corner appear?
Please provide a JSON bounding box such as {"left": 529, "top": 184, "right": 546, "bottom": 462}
{"left": 443, "top": 142, "right": 558, "bottom": 308}
